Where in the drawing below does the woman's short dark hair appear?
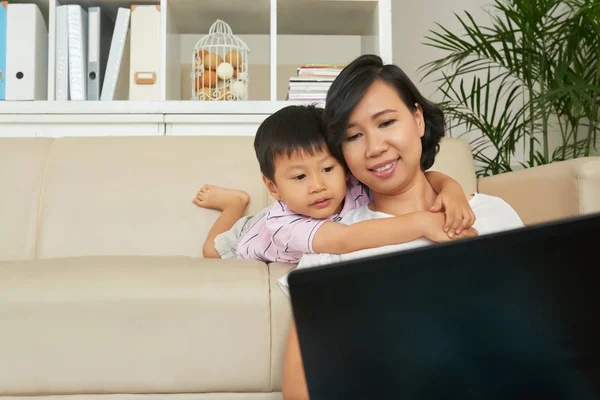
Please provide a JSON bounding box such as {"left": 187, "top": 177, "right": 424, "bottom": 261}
{"left": 323, "top": 54, "right": 446, "bottom": 171}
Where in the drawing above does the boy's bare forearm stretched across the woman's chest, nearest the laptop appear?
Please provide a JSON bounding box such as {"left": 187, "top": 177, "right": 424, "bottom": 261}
{"left": 312, "top": 211, "right": 477, "bottom": 254}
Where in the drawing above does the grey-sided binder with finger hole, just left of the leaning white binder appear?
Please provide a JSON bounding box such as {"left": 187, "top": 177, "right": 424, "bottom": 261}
{"left": 87, "top": 7, "right": 114, "bottom": 100}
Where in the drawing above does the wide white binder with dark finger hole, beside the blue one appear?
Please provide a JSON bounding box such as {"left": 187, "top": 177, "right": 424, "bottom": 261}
{"left": 5, "top": 3, "right": 48, "bottom": 100}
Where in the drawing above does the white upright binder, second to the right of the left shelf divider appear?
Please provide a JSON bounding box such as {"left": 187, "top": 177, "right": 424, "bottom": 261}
{"left": 67, "top": 4, "right": 88, "bottom": 100}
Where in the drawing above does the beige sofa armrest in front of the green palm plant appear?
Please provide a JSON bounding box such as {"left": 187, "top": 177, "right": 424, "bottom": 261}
{"left": 478, "top": 157, "right": 600, "bottom": 225}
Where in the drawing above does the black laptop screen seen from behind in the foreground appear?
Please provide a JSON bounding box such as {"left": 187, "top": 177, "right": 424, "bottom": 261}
{"left": 288, "top": 214, "right": 600, "bottom": 400}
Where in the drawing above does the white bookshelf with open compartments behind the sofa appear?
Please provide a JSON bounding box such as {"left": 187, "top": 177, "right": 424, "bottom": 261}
{"left": 0, "top": 0, "right": 392, "bottom": 136}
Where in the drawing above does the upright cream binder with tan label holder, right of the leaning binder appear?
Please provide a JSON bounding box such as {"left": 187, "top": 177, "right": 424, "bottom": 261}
{"left": 129, "top": 5, "right": 161, "bottom": 101}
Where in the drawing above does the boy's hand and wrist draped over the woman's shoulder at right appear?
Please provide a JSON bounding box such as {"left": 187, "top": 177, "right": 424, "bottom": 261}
{"left": 425, "top": 171, "right": 475, "bottom": 235}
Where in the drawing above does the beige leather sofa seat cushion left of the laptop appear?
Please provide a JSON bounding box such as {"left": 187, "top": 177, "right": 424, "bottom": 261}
{"left": 0, "top": 257, "right": 271, "bottom": 396}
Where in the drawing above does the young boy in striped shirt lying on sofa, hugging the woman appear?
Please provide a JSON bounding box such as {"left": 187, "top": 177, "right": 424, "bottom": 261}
{"left": 193, "top": 106, "right": 477, "bottom": 263}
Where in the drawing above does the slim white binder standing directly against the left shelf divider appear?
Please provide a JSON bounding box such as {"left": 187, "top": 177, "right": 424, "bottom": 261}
{"left": 54, "top": 6, "right": 70, "bottom": 101}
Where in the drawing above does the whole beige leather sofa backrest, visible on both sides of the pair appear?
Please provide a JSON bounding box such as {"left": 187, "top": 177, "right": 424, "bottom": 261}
{"left": 0, "top": 136, "right": 476, "bottom": 259}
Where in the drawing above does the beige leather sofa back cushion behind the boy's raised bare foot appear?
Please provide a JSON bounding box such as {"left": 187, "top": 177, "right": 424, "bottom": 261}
{"left": 37, "top": 136, "right": 267, "bottom": 258}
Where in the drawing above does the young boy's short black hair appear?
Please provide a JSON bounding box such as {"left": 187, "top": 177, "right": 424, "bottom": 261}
{"left": 254, "top": 104, "right": 327, "bottom": 181}
